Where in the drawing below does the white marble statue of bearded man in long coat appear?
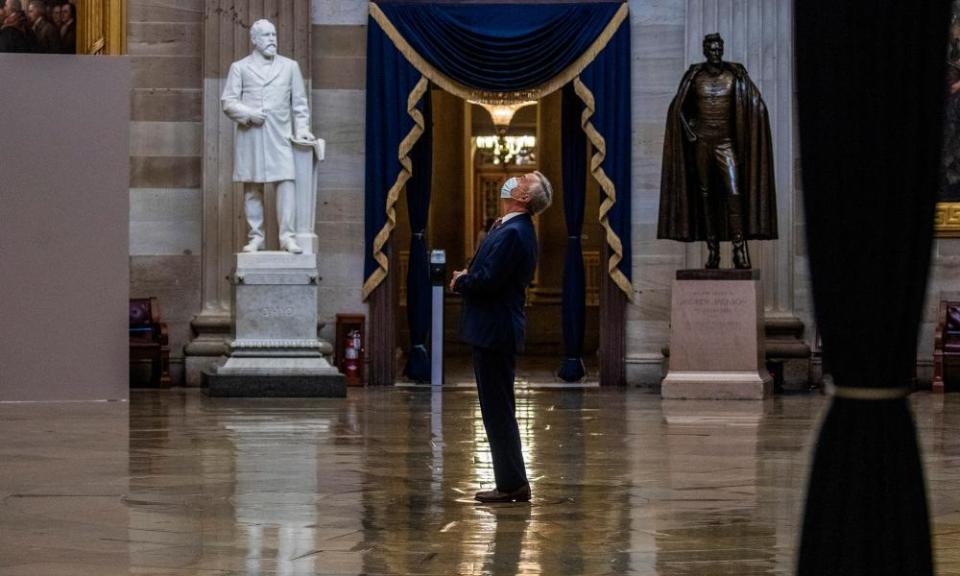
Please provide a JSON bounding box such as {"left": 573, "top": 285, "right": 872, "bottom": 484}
{"left": 221, "top": 20, "right": 315, "bottom": 254}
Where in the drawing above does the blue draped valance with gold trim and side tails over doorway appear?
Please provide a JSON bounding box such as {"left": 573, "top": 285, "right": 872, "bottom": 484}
{"left": 363, "top": 1, "right": 632, "bottom": 298}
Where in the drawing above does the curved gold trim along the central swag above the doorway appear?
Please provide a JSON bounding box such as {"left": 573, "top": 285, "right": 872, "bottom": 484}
{"left": 370, "top": 2, "right": 629, "bottom": 104}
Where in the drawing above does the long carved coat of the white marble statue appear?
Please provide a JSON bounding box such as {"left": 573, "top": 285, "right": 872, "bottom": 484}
{"left": 220, "top": 54, "right": 310, "bottom": 182}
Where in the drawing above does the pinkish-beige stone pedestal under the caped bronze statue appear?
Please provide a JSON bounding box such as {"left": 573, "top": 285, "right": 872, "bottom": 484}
{"left": 660, "top": 270, "right": 772, "bottom": 400}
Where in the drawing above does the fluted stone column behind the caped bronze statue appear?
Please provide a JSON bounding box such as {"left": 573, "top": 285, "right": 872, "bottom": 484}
{"left": 685, "top": 0, "right": 810, "bottom": 381}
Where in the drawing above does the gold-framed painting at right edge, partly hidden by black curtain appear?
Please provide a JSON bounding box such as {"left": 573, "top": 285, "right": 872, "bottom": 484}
{"left": 934, "top": 0, "right": 960, "bottom": 238}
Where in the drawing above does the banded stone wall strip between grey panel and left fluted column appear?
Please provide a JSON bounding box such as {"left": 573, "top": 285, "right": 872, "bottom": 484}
{"left": 127, "top": 0, "right": 203, "bottom": 382}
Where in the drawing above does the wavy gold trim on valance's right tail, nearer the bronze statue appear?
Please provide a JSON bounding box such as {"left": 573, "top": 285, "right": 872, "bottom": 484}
{"left": 573, "top": 76, "right": 633, "bottom": 302}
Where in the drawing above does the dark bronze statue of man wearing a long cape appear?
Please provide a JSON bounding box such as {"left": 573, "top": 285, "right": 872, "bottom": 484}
{"left": 657, "top": 34, "right": 777, "bottom": 268}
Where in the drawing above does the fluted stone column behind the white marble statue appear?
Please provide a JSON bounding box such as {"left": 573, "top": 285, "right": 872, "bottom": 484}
{"left": 184, "top": 0, "right": 311, "bottom": 386}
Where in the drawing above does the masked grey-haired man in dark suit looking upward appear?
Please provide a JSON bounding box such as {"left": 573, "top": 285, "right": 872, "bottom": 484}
{"left": 450, "top": 172, "right": 553, "bottom": 502}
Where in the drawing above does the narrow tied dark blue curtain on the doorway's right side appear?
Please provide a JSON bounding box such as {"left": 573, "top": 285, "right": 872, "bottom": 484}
{"left": 557, "top": 85, "right": 587, "bottom": 382}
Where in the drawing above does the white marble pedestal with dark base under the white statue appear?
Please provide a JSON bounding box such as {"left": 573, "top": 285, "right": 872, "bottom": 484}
{"left": 204, "top": 252, "right": 347, "bottom": 397}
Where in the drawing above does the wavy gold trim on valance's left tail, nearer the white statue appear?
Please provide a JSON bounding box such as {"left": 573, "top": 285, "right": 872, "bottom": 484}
{"left": 363, "top": 76, "right": 430, "bottom": 300}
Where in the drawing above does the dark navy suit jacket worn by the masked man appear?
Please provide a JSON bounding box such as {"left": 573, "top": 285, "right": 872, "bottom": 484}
{"left": 454, "top": 214, "right": 537, "bottom": 352}
